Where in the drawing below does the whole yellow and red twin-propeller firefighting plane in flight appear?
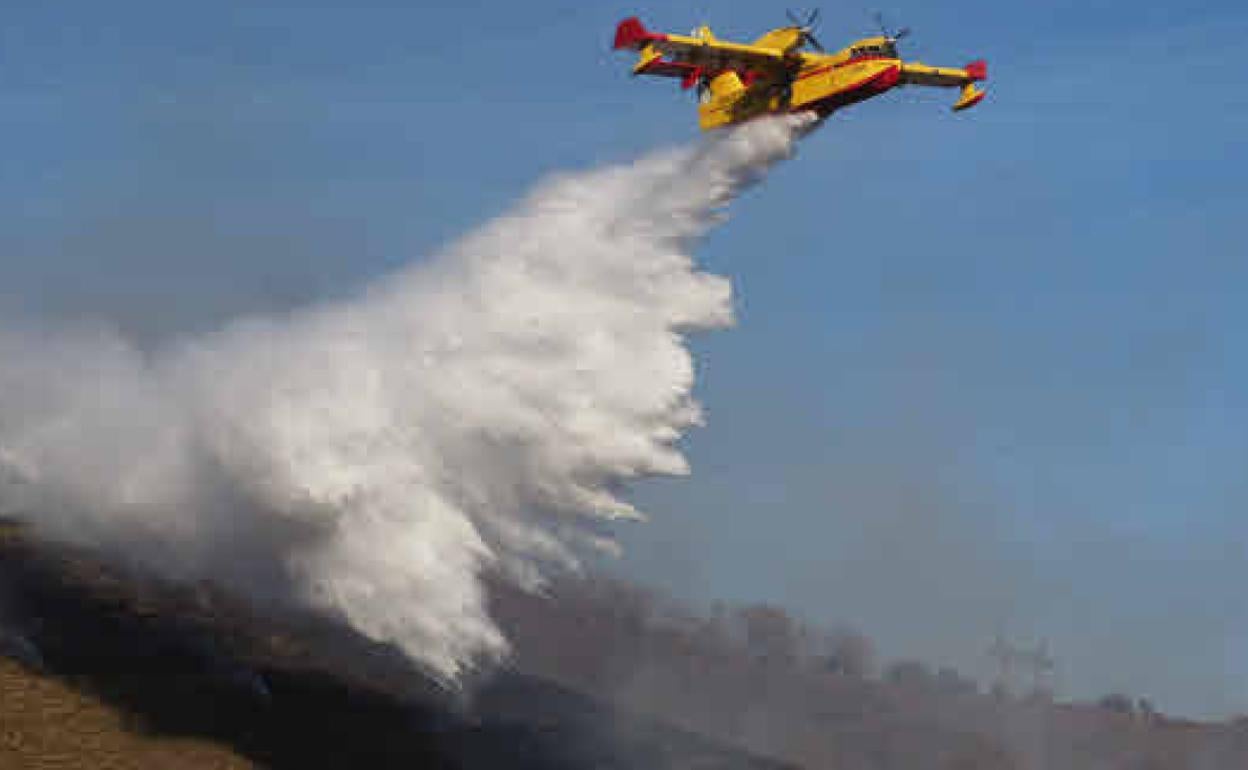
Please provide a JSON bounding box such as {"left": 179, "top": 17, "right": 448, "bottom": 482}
{"left": 615, "top": 17, "right": 988, "bottom": 130}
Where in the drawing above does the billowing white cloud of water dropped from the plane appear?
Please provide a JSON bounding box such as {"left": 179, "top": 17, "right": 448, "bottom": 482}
{"left": 0, "top": 116, "right": 810, "bottom": 680}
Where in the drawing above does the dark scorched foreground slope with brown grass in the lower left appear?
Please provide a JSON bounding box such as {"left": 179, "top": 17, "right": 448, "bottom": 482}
{"left": 0, "top": 528, "right": 781, "bottom": 770}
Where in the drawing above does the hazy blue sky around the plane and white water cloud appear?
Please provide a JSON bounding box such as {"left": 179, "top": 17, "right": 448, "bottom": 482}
{"left": 0, "top": 0, "right": 1248, "bottom": 714}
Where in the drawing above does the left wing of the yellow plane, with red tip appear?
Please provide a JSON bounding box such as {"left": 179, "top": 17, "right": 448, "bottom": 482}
{"left": 615, "top": 16, "right": 787, "bottom": 89}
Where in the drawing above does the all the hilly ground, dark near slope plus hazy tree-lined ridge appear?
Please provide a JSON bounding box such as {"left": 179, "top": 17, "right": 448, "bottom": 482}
{"left": 0, "top": 519, "right": 1248, "bottom": 770}
